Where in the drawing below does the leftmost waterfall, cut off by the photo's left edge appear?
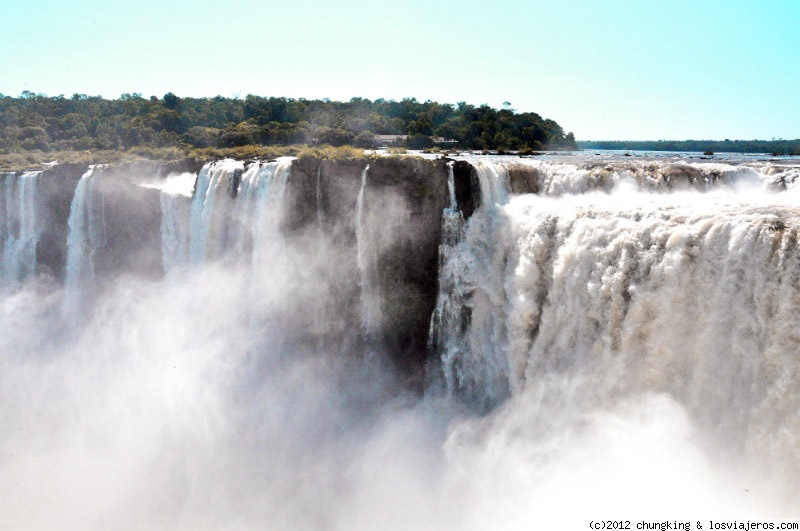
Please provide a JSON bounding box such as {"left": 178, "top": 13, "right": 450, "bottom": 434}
{"left": 0, "top": 172, "right": 42, "bottom": 287}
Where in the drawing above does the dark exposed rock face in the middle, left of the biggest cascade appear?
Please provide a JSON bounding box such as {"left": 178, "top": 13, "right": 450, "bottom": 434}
{"left": 286, "top": 158, "right": 448, "bottom": 374}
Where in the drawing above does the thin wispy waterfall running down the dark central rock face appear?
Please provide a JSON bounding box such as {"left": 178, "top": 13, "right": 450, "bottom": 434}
{"left": 355, "top": 164, "right": 381, "bottom": 338}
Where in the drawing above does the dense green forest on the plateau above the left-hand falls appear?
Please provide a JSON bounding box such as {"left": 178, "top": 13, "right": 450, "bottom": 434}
{"left": 0, "top": 91, "right": 576, "bottom": 153}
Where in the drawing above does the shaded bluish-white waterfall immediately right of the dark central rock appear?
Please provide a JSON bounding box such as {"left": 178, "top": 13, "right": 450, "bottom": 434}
{"left": 431, "top": 161, "right": 509, "bottom": 407}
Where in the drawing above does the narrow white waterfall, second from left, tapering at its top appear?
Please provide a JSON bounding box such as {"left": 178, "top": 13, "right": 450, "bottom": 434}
{"left": 64, "top": 166, "right": 106, "bottom": 314}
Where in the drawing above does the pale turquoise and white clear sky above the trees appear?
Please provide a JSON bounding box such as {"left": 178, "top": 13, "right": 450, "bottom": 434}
{"left": 0, "top": 0, "right": 800, "bottom": 140}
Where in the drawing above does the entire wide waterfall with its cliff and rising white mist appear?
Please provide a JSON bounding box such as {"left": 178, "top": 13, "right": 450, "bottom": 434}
{"left": 0, "top": 156, "right": 800, "bottom": 530}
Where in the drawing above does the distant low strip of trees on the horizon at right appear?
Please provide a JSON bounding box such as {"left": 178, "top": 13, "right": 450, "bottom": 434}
{"left": 578, "top": 139, "right": 800, "bottom": 155}
